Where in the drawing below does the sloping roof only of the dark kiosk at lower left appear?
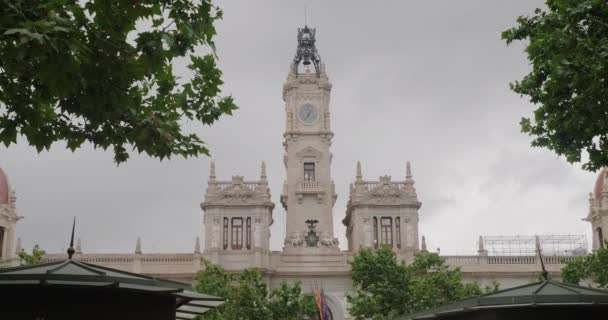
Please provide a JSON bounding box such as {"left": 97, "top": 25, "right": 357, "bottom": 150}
{"left": 0, "top": 260, "right": 224, "bottom": 319}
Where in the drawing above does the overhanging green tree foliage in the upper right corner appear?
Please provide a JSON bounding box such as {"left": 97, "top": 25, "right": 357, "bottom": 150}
{"left": 502, "top": 0, "right": 608, "bottom": 171}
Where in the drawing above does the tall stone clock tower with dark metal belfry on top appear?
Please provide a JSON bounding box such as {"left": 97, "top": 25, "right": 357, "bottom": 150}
{"left": 281, "top": 26, "right": 338, "bottom": 249}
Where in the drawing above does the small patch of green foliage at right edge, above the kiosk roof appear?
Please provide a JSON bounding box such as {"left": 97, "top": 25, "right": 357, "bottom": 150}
{"left": 561, "top": 242, "right": 608, "bottom": 288}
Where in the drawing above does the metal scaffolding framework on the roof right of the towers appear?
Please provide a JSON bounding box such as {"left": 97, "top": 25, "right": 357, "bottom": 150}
{"left": 478, "top": 235, "right": 587, "bottom": 256}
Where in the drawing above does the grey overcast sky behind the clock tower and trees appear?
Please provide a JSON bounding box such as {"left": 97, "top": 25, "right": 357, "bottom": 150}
{"left": 0, "top": 0, "right": 594, "bottom": 254}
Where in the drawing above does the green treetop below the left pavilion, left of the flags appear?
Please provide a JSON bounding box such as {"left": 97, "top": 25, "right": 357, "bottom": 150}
{"left": 195, "top": 261, "right": 319, "bottom": 320}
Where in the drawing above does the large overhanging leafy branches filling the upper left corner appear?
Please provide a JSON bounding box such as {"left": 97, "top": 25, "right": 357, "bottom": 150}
{"left": 0, "top": 0, "right": 236, "bottom": 163}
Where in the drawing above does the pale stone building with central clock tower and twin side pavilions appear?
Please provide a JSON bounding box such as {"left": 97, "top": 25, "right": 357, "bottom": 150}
{"left": 0, "top": 27, "right": 608, "bottom": 319}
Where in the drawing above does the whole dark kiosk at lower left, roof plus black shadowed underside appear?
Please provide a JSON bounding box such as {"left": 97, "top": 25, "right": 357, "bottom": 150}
{"left": 0, "top": 260, "right": 223, "bottom": 320}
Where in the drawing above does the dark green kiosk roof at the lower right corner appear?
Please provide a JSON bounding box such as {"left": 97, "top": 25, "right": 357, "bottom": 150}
{"left": 400, "top": 281, "right": 608, "bottom": 320}
